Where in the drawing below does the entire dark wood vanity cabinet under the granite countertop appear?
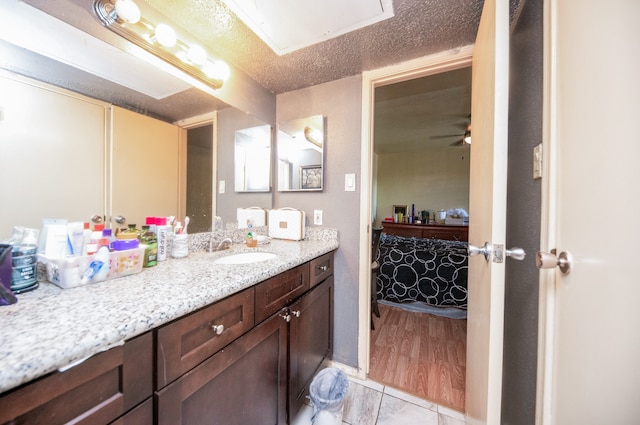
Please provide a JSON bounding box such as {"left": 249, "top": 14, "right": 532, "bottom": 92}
{"left": 0, "top": 252, "right": 334, "bottom": 425}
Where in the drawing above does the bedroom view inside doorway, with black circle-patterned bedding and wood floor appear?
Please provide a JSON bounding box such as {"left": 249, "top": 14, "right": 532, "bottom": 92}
{"left": 369, "top": 63, "right": 471, "bottom": 411}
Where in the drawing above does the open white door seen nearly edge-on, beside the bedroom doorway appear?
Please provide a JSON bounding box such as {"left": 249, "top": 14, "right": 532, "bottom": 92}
{"left": 465, "top": 0, "right": 509, "bottom": 424}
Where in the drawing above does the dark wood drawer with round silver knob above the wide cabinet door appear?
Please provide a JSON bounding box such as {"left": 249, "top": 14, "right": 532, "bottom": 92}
{"left": 156, "top": 288, "right": 255, "bottom": 389}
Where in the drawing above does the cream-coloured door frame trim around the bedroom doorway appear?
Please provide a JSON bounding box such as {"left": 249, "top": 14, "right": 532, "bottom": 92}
{"left": 358, "top": 46, "right": 472, "bottom": 410}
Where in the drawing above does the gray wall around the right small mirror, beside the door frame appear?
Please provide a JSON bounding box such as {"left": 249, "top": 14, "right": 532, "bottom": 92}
{"left": 274, "top": 76, "right": 362, "bottom": 367}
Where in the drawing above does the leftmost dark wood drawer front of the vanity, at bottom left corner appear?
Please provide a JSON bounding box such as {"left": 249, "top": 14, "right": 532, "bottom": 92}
{"left": 0, "top": 332, "right": 153, "bottom": 425}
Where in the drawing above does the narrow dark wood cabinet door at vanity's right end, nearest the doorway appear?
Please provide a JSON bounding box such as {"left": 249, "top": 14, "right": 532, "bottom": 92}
{"left": 289, "top": 276, "right": 333, "bottom": 418}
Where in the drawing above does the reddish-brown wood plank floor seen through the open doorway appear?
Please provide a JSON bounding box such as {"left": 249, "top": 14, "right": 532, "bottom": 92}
{"left": 369, "top": 305, "right": 467, "bottom": 411}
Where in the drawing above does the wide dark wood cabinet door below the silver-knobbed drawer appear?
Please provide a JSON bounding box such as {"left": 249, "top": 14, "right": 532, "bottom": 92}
{"left": 156, "top": 315, "right": 287, "bottom": 425}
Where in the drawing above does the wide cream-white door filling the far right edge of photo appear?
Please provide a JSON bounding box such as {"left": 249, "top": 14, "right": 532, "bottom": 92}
{"left": 538, "top": 0, "right": 640, "bottom": 425}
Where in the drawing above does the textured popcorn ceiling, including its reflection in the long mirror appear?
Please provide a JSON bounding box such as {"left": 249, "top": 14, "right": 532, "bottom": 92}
{"left": 0, "top": 0, "right": 518, "bottom": 125}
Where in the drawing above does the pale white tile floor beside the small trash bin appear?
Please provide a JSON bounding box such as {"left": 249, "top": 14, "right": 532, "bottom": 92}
{"left": 292, "top": 377, "right": 465, "bottom": 425}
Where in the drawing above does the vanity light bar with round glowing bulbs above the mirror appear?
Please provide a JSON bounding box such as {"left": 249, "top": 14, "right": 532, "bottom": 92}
{"left": 93, "top": 0, "right": 230, "bottom": 89}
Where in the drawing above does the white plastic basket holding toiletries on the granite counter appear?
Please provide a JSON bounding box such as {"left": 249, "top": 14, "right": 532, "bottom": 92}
{"left": 40, "top": 245, "right": 146, "bottom": 289}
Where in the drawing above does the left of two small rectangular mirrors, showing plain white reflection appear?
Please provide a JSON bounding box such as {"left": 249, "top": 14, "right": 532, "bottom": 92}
{"left": 234, "top": 125, "right": 271, "bottom": 192}
